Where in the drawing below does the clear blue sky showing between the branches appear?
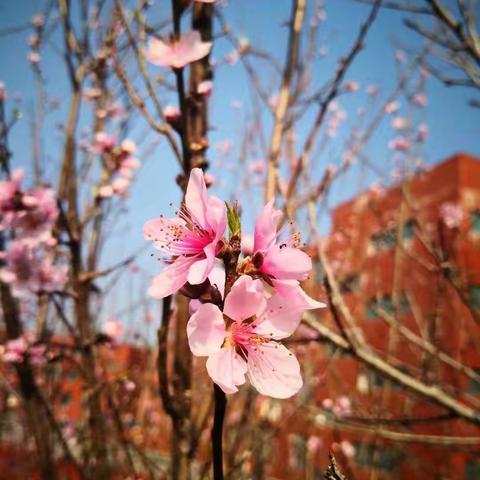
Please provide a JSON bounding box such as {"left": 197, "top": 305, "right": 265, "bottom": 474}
{"left": 0, "top": 0, "right": 480, "bottom": 334}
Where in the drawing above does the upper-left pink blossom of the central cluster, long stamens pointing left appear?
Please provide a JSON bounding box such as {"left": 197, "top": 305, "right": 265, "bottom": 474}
{"left": 144, "top": 168, "right": 227, "bottom": 298}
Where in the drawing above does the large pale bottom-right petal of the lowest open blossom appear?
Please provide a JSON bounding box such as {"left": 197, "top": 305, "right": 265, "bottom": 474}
{"left": 248, "top": 342, "right": 303, "bottom": 398}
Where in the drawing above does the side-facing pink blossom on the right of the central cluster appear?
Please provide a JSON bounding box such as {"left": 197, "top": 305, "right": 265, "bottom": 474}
{"left": 248, "top": 200, "right": 325, "bottom": 310}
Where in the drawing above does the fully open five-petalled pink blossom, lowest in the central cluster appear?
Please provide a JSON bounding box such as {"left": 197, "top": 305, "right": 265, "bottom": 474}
{"left": 187, "top": 275, "right": 303, "bottom": 398}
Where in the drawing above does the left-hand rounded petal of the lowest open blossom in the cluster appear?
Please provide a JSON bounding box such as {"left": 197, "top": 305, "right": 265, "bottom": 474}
{"left": 187, "top": 303, "right": 226, "bottom": 357}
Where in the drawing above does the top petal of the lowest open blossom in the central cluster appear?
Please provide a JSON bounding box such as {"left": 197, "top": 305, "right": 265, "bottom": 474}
{"left": 223, "top": 275, "right": 266, "bottom": 322}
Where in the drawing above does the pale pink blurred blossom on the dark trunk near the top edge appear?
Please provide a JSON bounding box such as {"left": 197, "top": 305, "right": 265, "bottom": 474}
{"left": 145, "top": 30, "right": 212, "bottom": 68}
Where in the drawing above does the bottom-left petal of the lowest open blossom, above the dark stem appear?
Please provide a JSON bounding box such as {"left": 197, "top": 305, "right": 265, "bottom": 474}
{"left": 207, "top": 347, "right": 247, "bottom": 393}
